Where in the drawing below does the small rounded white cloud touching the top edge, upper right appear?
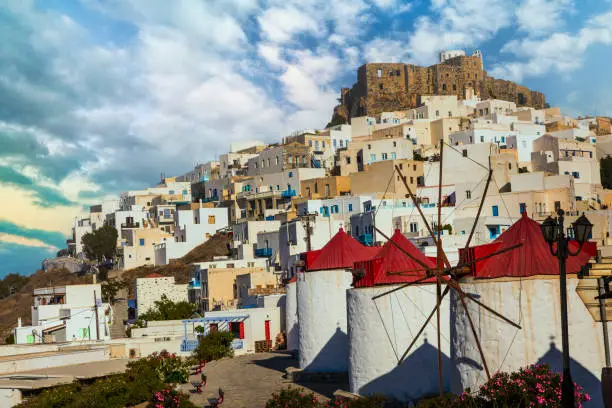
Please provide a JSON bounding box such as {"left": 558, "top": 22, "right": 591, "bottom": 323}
{"left": 516, "top": 0, "right": 574, "bottom": 35}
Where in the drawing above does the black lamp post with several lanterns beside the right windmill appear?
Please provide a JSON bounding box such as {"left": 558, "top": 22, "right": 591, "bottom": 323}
{"left": 540, "top": 210, "right": 593, "bottom": 408}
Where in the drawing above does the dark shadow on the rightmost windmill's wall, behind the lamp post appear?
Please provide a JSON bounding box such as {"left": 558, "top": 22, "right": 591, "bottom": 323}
{"left": 536, "top": 342, "right": 604, "bottom": 408}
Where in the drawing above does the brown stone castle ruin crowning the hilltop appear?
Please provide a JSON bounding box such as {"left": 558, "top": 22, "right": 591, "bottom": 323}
{"left": 332, "top": 50, "right": 546, "bottom": 124}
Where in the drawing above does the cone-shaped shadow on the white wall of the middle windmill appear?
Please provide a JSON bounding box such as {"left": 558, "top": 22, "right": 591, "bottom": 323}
{"left": 359, "top": 339, "right": 461, "bottom": 403}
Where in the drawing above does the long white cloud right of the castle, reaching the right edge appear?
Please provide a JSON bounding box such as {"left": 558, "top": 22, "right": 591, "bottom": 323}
{"left": 490, "top": 11, "right": 612, "bottom": 82}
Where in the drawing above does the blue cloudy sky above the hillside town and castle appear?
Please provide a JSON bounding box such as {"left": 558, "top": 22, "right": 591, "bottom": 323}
{"left": 0, "top": 0, "right": 612, "bottom": 277}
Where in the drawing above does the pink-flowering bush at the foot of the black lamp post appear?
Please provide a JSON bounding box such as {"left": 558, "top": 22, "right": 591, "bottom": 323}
{"left": 459, "top": 364, "right": 591, "bottom": 408}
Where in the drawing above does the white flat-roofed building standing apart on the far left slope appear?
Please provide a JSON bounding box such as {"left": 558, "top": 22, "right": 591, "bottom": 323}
{"left": 13, "top": 284, "right": 112, "bottom": 344}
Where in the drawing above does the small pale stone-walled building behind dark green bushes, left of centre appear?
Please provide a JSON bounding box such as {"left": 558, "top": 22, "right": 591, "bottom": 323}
{"left": 134, "top": 274, "right": 188, "bottom": 316}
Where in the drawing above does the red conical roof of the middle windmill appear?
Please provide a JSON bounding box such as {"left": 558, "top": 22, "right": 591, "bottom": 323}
{"left": 354, "top": 230, "right": 436, "bottom": 287}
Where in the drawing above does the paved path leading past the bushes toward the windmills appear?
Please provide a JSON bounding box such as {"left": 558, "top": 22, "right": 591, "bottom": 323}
{"left": 181, "top": 353, "right": 347, "bottom": 408}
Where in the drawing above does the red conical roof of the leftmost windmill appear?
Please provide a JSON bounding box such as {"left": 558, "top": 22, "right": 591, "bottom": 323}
{"left": 306, "top": 228, "right": 378, "bottom": 271}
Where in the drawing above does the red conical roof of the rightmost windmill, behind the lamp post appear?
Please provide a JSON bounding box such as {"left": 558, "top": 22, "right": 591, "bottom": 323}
{"left": 460, "top": 212, "right": 597, "bottom": 278}
